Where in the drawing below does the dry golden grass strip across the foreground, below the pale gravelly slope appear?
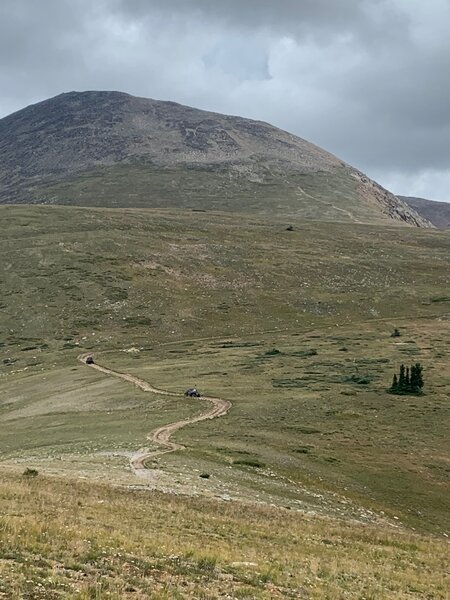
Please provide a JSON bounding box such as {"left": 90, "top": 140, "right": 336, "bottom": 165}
{"left": 0, "top": 472, "right": 449, "bottom": 600}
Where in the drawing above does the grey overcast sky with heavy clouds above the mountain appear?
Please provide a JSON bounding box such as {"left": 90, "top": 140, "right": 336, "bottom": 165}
{"left": 0, "top": 0, "right": 450, "bottom": 201}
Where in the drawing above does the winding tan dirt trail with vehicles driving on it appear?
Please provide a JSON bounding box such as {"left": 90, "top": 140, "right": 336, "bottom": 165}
{"left": 78, "top": 354, "right": 231, "bottom": 471}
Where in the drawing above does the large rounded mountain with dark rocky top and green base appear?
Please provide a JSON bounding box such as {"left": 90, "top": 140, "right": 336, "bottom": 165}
{"left": 0, "top": 92, "right": 431, "bottom": 227}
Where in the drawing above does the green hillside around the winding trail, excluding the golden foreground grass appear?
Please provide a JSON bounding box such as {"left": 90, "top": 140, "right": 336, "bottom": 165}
{"left": 0, "top": 207, "right": 450, "bottom": 533}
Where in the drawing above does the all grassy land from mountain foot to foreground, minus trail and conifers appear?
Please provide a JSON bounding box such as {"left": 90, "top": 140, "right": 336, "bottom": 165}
{"left": 0, "top": 206, "right": 450, "bottom": 599}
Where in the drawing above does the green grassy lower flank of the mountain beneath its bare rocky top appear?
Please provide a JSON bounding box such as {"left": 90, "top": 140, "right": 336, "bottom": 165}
{"left": 35, "top": 162, "right": 372, "bottom": 223}
